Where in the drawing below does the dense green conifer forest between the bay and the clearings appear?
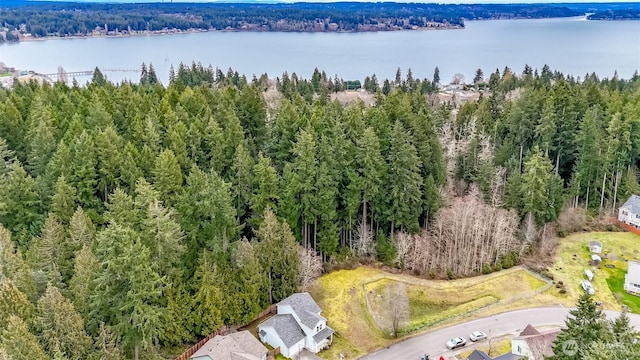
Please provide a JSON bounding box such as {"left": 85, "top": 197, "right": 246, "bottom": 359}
{"left": 0, "top": 64, "right": 640, "bottom": 359}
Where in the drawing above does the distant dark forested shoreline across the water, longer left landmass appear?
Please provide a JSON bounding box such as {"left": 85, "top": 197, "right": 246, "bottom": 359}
{"left": 0, "top": 1, "right": 584, "bottom": 41}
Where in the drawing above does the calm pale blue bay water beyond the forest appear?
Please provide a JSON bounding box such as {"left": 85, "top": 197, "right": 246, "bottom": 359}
{"left": 0, "top": 18, "right": 640, "bottom": 83}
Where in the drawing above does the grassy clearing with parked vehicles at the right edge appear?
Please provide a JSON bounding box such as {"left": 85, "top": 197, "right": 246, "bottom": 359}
{"left": 550, "top": 232, "right": 640, "bottom": 312}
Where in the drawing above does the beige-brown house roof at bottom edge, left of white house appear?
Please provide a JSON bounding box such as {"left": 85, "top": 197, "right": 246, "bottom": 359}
{"left": 191, "top": 330, "right": 268, "bottom": 360}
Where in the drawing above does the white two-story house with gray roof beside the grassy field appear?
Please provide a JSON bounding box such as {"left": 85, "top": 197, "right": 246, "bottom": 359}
{"left": 258, "top": 292, "right": 334, "bottom": 358}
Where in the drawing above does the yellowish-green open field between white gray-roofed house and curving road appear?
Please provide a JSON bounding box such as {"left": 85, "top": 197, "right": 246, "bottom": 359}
{"left": 311, "top": 266, "right": 545, "bottom": 359}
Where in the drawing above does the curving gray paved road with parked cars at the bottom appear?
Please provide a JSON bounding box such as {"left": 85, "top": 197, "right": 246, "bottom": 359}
{"left": 361, "top": 307, "right": 640, "bottom": 360}
